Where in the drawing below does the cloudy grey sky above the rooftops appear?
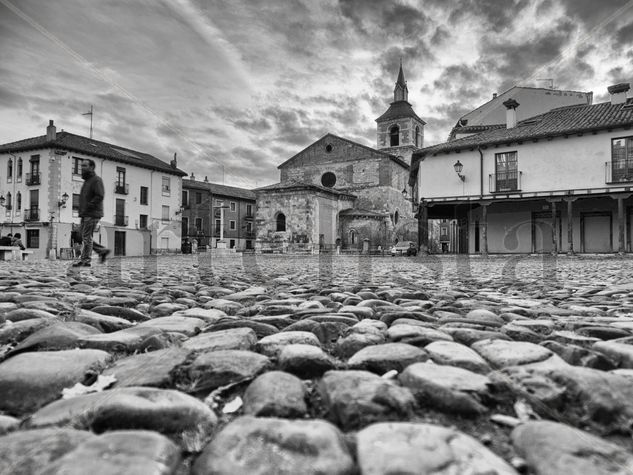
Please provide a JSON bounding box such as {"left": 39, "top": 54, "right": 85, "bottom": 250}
{"left": 0, "top": 0, "right": 633, "bottom": 187}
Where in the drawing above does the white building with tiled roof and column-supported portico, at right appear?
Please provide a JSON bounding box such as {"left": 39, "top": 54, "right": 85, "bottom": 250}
{"left": 410, "top": 84, "right": 633, "bottom": 254}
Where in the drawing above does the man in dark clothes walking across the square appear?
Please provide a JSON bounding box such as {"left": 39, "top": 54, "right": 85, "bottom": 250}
{"left": 73, "top": 159, "right": 110, "bottom": 267}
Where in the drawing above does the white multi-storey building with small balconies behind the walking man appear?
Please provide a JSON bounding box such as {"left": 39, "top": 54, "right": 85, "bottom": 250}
{"left": 0, "top": 121, "right": 186, "bottom": 258}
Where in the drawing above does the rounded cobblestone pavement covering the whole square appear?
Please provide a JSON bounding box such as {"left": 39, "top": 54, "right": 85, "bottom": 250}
{"left": 0, "top": 254, "right": 633, "bottom": 475}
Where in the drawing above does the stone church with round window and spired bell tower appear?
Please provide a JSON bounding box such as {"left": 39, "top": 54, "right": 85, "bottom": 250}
{"left": 255, "top": 65, "right": 425, "bottom": 252}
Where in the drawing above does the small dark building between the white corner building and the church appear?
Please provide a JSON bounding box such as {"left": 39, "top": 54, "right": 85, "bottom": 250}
{"left": 182, "top": 178, "right": 256, "bottom": 251}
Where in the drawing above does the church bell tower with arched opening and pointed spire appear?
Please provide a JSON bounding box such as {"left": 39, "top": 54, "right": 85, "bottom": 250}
{"left": 376, "top": 60, "right": 426, "bottom": 163}
